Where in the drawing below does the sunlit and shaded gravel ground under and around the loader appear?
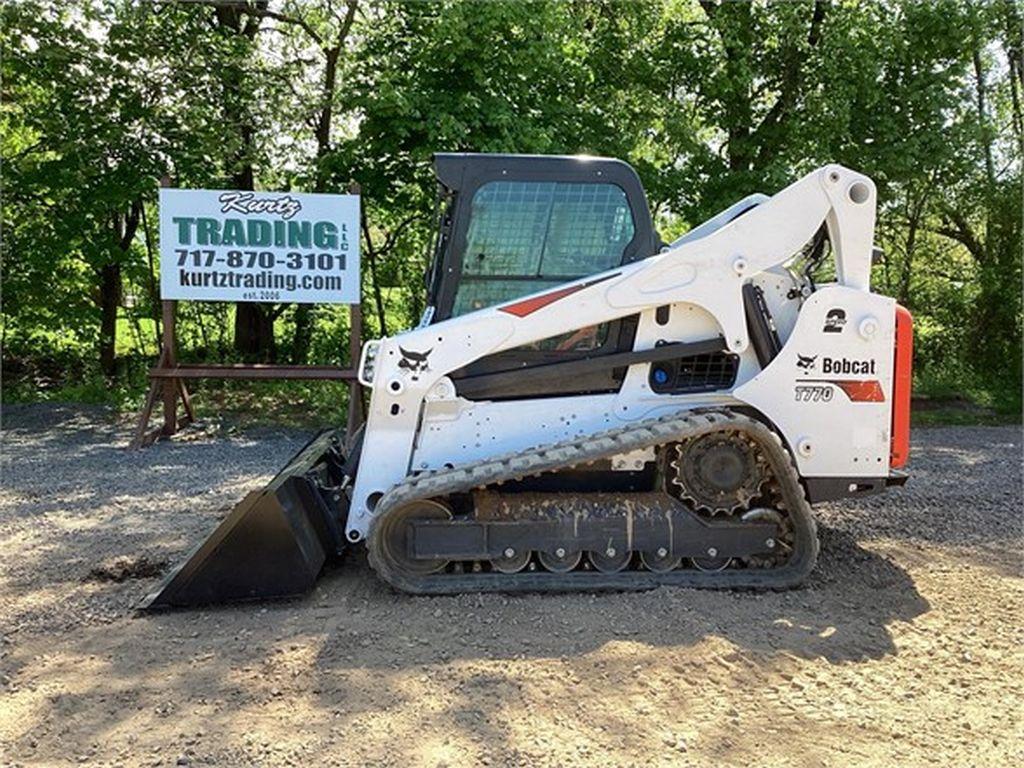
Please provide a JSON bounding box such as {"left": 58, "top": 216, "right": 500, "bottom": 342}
{"left": 0, "top": 406, "right": 1024, "bottom": 768}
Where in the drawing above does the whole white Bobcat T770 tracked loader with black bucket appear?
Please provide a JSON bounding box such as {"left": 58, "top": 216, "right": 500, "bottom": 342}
{"left": 144, "top": 155, "right": 911, "bottom": 608}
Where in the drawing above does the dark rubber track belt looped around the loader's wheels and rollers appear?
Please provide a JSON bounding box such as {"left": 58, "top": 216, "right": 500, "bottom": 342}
{"left": 368, "top": 410, "right": 818, "bottom": 595}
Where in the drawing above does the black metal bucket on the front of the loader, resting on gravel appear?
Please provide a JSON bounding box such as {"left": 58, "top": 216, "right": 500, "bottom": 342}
{"left": 139, "top": 430, "right": 347, "bottom": 610}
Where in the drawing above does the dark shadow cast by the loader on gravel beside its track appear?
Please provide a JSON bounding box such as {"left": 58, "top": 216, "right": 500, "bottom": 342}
{"left": 301, "top": 528, "right": 930, "bottom": 668}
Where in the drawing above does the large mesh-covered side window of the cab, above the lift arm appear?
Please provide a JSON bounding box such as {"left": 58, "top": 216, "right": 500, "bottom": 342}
{"left": 453, "top": 181, "right": 636, "bottom": 315}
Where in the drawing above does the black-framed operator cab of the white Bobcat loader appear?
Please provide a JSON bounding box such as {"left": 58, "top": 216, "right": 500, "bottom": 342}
{"left": 424, "top": 154, "right": 662, "bottom": 399}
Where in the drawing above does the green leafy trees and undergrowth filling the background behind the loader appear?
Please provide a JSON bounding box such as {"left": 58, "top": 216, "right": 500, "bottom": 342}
{"left": 0, "top": 0, "right": 1024, "bottom": 428}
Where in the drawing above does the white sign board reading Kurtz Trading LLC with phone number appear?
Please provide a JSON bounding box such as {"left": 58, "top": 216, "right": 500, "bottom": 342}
{"left": 160, "top": 188, "right": 359, "bottom": 304}
